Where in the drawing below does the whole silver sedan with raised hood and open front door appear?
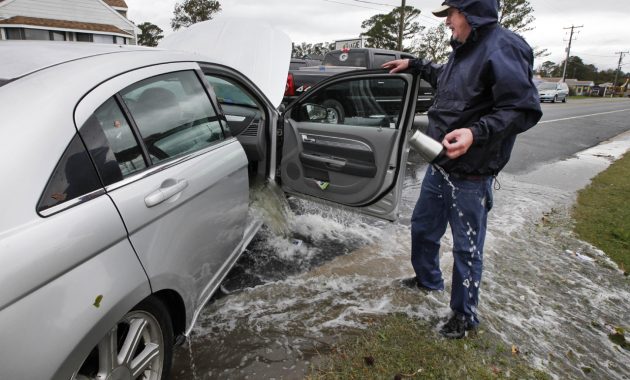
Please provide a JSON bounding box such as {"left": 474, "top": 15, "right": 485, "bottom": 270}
{"left": 0, "top": 18, "right": 430, "bottom": 380}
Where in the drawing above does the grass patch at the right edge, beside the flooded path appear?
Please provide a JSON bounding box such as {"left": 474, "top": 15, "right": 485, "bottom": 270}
{"left": 573, "top": 154, "right": 630, "bottom": 274}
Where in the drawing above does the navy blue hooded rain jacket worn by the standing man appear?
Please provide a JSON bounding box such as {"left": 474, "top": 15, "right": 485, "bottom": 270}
{"left": 409, "top": 0, "right": 542, "bottom": 175}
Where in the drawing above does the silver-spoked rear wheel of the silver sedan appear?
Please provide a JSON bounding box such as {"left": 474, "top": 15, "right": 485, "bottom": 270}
{"left": 71, "top": 297, "right": 173, "bottom": 380}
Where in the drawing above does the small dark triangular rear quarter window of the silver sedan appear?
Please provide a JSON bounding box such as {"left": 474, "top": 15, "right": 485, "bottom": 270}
{"left": 37, "top": 135, "right": 101, "bottom": 211}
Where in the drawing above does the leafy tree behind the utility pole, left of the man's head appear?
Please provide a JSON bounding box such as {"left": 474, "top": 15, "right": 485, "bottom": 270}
{"left": 361, "top": 6, "right": 424, "bottom": 51}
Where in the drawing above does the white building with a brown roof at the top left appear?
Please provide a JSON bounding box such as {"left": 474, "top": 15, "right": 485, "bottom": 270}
{"left": 0, "top": 0, "right": 140, "bottom": 45}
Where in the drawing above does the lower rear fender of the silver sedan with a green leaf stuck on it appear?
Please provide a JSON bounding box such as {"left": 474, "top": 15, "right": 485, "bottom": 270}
{"left": 0, "top": 239, "right": 151, "bottom": 379}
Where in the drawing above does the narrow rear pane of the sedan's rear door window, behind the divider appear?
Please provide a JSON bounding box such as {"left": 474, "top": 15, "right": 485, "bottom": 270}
{"left": 80, "top": 98, "right": 146, "bottom": 177}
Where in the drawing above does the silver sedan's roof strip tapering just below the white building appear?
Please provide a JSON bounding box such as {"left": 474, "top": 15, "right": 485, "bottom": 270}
{"left": 0, "top": 41, "right": 153, "bottom": 84}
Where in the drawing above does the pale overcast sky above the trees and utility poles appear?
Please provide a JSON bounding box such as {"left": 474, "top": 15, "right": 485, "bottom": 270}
{"left": 125, "top": 0, "right": 630, "bottom": 72}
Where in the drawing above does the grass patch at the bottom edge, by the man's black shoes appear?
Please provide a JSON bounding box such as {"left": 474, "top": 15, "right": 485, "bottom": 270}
{"left": 308, "top": 314, "right": 549, "bottom": 379}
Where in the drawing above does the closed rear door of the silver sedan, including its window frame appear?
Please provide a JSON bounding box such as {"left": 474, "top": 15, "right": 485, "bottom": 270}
{"left": 76, "top": 62, "right": 249, "bottom": 322}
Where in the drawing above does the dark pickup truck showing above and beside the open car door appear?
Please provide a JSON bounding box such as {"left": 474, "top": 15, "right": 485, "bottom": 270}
{"left": 282, "top": 48, "right": 434, "bottom": 112}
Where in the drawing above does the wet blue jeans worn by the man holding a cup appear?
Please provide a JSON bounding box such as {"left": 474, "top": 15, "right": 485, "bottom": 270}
{"left": 411, "top": 166, "right": 492, "bottom": 326}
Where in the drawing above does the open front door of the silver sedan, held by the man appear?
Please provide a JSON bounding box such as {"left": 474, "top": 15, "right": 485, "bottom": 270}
{"left": 280, "top": 70, "right": 418, "bottom": 220}
